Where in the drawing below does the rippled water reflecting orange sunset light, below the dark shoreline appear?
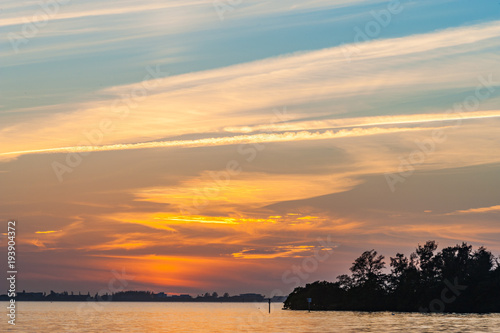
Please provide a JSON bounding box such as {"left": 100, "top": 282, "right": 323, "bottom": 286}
{"left": 0, "top": 302, "right": 500, "bottom": 333}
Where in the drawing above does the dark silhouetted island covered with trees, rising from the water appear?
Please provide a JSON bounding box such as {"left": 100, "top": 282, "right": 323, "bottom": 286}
{"left": 284, "top": 241, "right": 500, "bottom": 313}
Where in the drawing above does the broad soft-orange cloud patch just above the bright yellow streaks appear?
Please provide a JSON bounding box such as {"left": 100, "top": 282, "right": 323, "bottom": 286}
{"left": 133, "top": 172, "right": 359, "bottom": 215}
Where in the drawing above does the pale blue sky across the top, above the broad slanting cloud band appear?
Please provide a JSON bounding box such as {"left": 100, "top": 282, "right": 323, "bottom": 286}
{"left": 0, "top": 1, "right": 500, "bottom": 110}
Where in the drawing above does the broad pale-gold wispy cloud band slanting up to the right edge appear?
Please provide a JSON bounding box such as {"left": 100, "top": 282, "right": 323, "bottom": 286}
{"left": 0, "top": 22, "right": 500, "bottom": 159}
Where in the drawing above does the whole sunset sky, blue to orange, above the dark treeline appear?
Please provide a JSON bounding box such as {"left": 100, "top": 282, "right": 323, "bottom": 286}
{"left": 0, "top": 0, "right": 500, "bottom": 296}
